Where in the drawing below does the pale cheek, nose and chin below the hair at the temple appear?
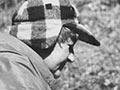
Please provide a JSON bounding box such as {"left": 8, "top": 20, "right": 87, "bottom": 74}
{"left": 44, "top": 43, "right": 74, "bottom": 77}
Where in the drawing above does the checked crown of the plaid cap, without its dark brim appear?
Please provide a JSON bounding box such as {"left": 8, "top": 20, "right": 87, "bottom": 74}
{"left": 10, "top": 0, "right": 76, "bottom": 49}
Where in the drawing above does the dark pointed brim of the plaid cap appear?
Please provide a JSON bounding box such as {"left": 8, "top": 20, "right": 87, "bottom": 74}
{"left": 63, "top": 23, "right": 100, "bottom": 46}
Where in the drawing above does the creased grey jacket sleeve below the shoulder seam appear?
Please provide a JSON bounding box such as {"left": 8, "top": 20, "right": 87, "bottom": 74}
{"left": 0, "top": 52, "right": 50, "bottom": 90}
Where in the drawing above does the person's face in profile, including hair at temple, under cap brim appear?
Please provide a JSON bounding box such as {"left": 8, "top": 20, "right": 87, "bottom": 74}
{"left": 44, "top": 27, "right": 76, "bottom": 77}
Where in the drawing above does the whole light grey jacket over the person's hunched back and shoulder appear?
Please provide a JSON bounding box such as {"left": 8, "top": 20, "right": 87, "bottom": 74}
{"left": 0, "top": 33, "right": 56, "bottom": 90}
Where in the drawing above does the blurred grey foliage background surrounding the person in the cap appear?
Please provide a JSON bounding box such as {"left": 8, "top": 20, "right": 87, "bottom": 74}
{"left": 0, "top": 0, "right": 120, "bottom": 90}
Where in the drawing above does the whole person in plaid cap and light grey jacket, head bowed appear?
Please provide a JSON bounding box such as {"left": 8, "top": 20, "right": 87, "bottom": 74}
{"left": 0, "top": 0, "right": 99, "bottom": 90}
